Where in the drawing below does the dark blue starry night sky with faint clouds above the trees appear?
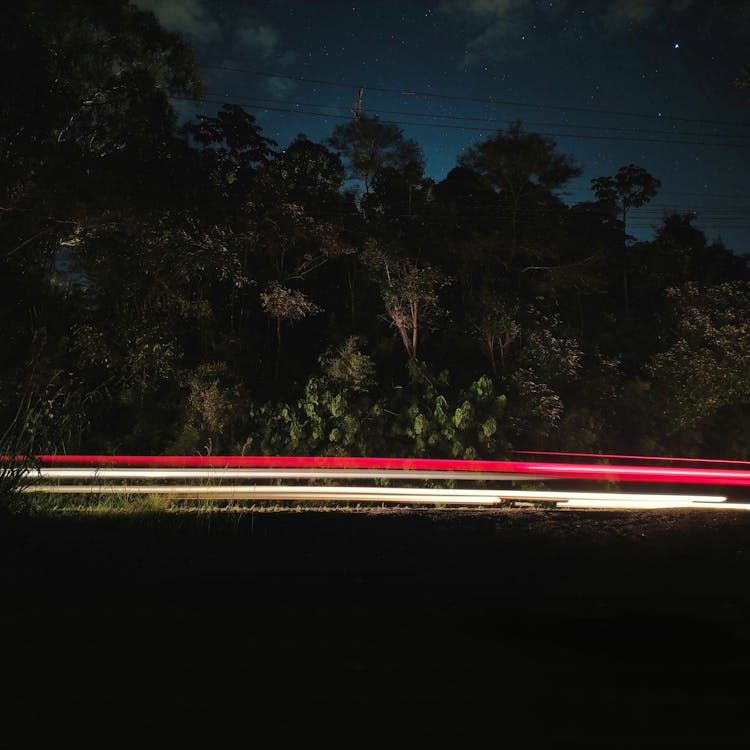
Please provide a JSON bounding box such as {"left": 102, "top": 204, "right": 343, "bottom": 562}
{"left": 136, "top": 0, "right": 750, "bottom": 253}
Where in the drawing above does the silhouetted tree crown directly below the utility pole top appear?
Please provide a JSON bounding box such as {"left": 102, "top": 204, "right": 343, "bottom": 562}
{"left": 327, "top": 115, "right": 424, "bottom": 195}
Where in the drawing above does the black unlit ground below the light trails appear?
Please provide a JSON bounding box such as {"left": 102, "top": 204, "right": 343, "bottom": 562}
{"left": 0, "top": 510, "right": 750, "bottom": 747}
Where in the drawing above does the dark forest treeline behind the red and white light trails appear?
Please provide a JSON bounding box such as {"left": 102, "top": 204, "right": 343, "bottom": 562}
{"left": 0, "top": 0, "right": 750, "bottom": 458}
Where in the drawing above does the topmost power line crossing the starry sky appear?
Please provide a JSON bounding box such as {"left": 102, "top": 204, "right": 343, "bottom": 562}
{"left": 200, "top": 64, "right": 750, "bottom": 127}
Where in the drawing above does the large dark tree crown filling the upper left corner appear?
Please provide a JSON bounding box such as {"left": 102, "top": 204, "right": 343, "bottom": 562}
{"left": 0, "top": 0, "right": 202, "bottom": 214}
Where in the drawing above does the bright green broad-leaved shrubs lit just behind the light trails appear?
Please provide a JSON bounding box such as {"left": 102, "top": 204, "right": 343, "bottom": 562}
{"left": 242, "top": 352, "right": 509, "bottom": 458}
